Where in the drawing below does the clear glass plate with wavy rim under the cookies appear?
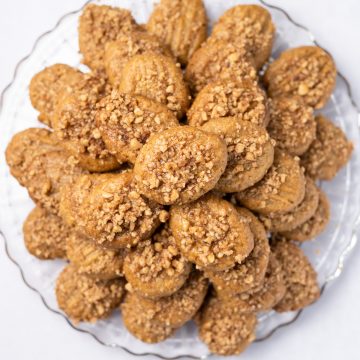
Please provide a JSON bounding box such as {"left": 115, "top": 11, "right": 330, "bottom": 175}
{"left": 0, "top": 0, "right": 360, "bottom": 359}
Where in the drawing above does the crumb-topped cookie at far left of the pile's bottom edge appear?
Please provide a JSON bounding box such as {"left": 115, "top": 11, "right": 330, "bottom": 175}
{"left": 56, "top": 265, "right": 125, "bottom": 323}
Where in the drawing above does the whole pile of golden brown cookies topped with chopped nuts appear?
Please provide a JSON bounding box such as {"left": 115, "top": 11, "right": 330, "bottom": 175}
{"left": 6, "top": 0, "right": 352, "bottom": 355}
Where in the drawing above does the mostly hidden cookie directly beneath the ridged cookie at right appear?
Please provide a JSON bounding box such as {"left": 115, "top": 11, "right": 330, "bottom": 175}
{"left": 260, "top": 177, "right": 319, "bottom": 232}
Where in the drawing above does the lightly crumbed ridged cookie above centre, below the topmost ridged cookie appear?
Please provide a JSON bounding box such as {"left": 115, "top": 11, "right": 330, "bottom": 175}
{"left": 119, "top": 53, "right": 189, "bottom": 118}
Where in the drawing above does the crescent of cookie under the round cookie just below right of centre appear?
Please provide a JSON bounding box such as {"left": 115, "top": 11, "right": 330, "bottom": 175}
{"left": 205, "top": 207, "right": 270, "bottom": 297}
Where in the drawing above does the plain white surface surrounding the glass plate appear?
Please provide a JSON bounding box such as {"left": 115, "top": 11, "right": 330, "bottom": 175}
{"left": 0, "top": 0, "right": 360, "bottom": 360}
